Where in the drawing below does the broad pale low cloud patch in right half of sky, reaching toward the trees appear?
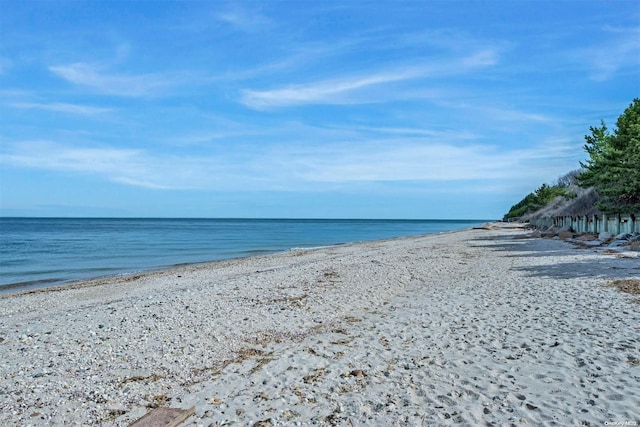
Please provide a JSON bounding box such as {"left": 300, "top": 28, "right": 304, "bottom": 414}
{"left": 270, "top": 139, "right": 576, "bottom": 183}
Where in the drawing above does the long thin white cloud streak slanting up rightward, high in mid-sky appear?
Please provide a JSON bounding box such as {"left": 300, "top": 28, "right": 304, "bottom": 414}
{"left": 240, "top": 50, "right": 498, "bottom": 109}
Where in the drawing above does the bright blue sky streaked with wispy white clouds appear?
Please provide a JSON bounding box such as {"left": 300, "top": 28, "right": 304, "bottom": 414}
{"left": 0, "top": 0, "right": 640, "bottom": 219}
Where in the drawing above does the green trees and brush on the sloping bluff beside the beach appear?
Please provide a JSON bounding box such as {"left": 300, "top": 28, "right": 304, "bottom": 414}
{"left": 504, "top": 98, "right": 640, "bottom": 220}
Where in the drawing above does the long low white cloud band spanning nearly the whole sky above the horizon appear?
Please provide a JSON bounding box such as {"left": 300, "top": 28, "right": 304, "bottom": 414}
{"left": 0, "top": 130, "right": 577, "bottom": 191}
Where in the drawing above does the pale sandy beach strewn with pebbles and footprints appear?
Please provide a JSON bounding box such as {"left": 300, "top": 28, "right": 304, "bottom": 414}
{"left": 0, "top": 229, "right": 640, "bottom": 426}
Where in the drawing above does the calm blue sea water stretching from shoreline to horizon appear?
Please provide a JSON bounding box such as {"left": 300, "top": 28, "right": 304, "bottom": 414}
{"left": 0, "top": 218, "right": 484, "bottom": 292}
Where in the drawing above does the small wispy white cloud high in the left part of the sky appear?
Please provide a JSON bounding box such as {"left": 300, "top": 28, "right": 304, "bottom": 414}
{"left": 49, "top": 62, "right": 175, "bottom": 97}
